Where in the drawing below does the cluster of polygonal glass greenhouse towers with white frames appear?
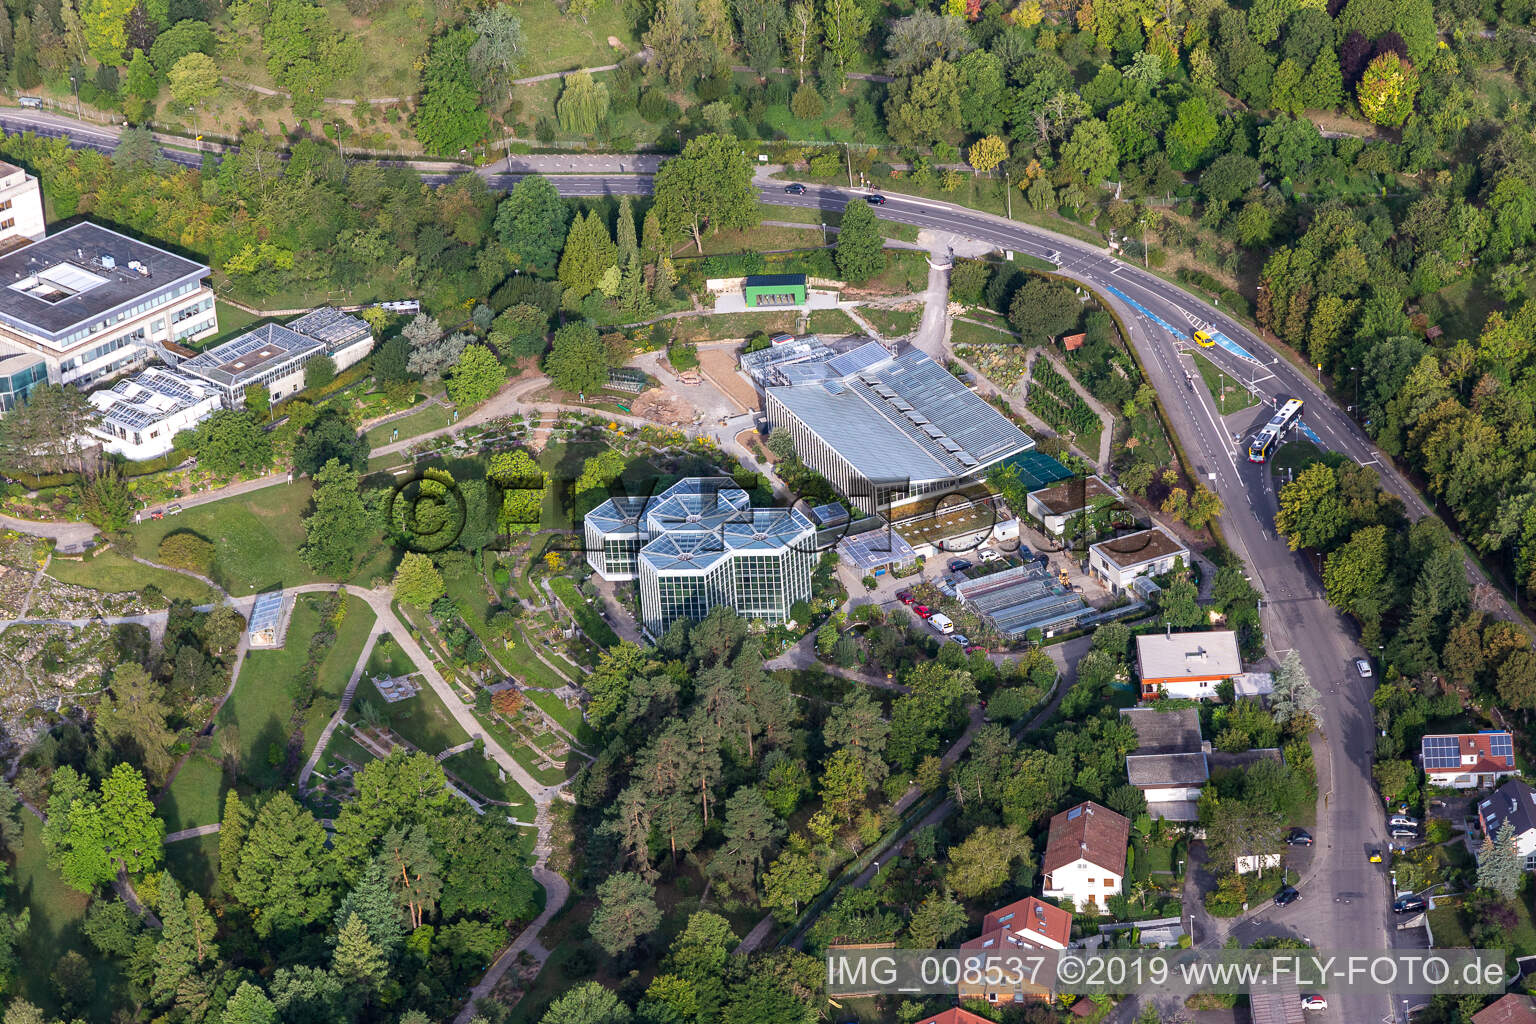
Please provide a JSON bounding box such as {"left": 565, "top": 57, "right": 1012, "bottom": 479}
{"left": 584, "top": 477, "right": 819, "bottom": 637}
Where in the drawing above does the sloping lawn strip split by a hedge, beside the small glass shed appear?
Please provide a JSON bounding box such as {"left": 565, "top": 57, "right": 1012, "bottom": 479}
{"left": 215, "top": 594, "right": 373, "bottom": 789}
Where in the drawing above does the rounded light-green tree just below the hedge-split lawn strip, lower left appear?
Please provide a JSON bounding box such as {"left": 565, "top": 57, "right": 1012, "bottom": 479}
{"left": 230, "top": 791, "right": 336, "bottom": 938}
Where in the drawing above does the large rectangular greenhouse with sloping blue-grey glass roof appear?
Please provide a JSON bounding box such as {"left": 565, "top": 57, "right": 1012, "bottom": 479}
{"left": 765, "top": 344, "right": 1035, "bottom": 513}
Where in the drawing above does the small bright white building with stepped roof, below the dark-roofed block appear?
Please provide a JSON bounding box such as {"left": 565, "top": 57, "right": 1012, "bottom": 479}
{"left": 88, "top": 365, "right": 220, "bottom": 459}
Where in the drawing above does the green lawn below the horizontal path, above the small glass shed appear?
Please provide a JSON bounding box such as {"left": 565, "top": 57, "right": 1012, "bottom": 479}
{"left": 132, "top": 479, "right": 395, "bottom": 596}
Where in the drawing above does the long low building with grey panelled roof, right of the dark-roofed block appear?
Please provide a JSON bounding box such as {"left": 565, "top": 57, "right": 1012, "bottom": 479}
{"left": 178, "top": 307, "right": 373, "bottom": 408}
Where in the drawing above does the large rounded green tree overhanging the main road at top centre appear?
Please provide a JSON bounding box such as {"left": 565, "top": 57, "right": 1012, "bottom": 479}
{"left": 653, "top": 135, "right": 757, "bottom": 253}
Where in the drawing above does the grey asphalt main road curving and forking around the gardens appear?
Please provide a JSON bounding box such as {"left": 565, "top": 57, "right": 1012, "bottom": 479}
{"left": 0, "top": 112, "right": 1443, "bottom": 1024}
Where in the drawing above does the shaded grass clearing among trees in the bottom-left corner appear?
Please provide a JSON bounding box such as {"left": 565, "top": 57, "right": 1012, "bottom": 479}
{"left": 11, "top": 811, "right": 118, "bottom": 1021}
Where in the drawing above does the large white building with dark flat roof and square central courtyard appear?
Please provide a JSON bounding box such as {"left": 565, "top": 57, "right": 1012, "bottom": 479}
{"left": 0, "top": 221, "right": 218, "bottom": 387}
